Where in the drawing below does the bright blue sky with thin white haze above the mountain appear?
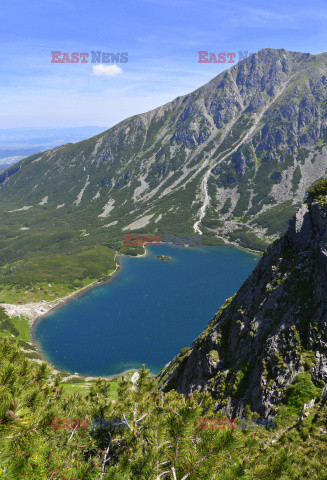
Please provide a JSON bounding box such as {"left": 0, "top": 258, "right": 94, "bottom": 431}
{"left": 0, "top": 0, "right": 327, "bottom": 128}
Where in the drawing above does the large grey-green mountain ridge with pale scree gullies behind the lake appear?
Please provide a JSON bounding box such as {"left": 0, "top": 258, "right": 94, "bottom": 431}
{"left": 0, "top": 49, "right": 327, "bottom": 284}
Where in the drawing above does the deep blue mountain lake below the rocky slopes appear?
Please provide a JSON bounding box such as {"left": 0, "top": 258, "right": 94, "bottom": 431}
{"left": 34, "top": 245, "right": 257, "bottom": 376}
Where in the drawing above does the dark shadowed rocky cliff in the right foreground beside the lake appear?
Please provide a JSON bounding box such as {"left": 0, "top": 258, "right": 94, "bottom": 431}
{"left": 160, "top": 202, "right": 327, "bottom": 415}
